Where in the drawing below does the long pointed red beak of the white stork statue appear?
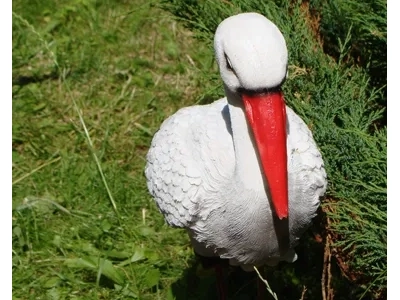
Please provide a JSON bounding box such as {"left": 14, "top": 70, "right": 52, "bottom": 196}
{"left": 242, "top": 91, "right": 288, "bottom": 220}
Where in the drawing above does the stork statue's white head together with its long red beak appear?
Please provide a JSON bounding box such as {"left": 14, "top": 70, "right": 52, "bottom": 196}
{"left": 214, "top": 13, "right": 288, "bottom": 219}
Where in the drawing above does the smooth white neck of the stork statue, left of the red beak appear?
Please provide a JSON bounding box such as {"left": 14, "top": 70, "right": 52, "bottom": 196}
{"left": 225, "top": 88, "right": 263, "bottom": 189}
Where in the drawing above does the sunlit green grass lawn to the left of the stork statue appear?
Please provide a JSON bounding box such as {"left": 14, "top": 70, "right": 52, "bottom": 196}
{"left": 12, "top": 1, "right": 210, "bottom": 299}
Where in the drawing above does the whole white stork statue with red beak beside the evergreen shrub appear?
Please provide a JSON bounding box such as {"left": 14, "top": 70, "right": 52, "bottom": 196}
{"left": 145, "top": 13, "right": 327, "bottom": 300}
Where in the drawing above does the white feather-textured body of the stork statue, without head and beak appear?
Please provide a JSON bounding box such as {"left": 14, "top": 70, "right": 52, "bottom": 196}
{"left": 145, "top": 98, "right": 327, "bottom": 269}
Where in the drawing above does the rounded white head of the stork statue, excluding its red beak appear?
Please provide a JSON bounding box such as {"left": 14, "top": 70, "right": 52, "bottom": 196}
{"left": 214, "top": 13, "right": 288, "bottom": 92}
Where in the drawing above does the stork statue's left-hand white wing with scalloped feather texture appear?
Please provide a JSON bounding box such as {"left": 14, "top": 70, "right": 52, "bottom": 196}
{"left": 145, "top": 100, "right": 233, "bottom": 227}
